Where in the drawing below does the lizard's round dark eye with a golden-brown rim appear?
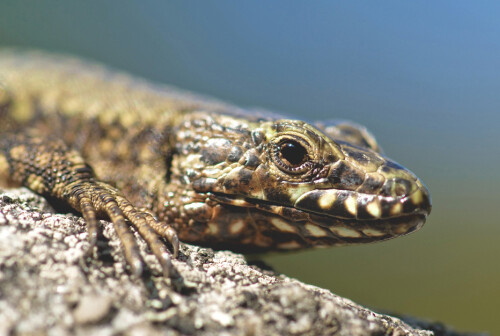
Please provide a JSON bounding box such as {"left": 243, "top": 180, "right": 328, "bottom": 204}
{"left": 274, "top": 139, "right": 309, "bottom": 174}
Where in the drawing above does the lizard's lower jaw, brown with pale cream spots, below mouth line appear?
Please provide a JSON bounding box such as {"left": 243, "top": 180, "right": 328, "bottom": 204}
{"left": 210, "top": 190, "right": 430, "bottom": 250}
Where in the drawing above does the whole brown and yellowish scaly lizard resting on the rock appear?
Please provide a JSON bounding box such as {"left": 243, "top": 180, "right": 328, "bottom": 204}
{"left": 0, "top": 49, "right": 431, "bottom": 275}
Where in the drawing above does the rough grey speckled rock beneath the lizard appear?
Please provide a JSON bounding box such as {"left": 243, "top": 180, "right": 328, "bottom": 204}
{"left": 0, "top": 189, "right": 484, "bottom": 336}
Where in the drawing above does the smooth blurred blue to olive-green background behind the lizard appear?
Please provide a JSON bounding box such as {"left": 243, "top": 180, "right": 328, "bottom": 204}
{"left": 0, "top": 0, "right": 500, "bottom": 334}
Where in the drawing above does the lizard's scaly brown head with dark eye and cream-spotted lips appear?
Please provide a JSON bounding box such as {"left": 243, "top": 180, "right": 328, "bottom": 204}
{"left": 171, "top": 113, "right": 431, "bottom": 251}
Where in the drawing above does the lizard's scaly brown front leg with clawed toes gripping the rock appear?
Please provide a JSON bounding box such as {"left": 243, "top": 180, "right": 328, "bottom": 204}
{"left": 0, "top": 133, "right": 179, "bottom": 276}
